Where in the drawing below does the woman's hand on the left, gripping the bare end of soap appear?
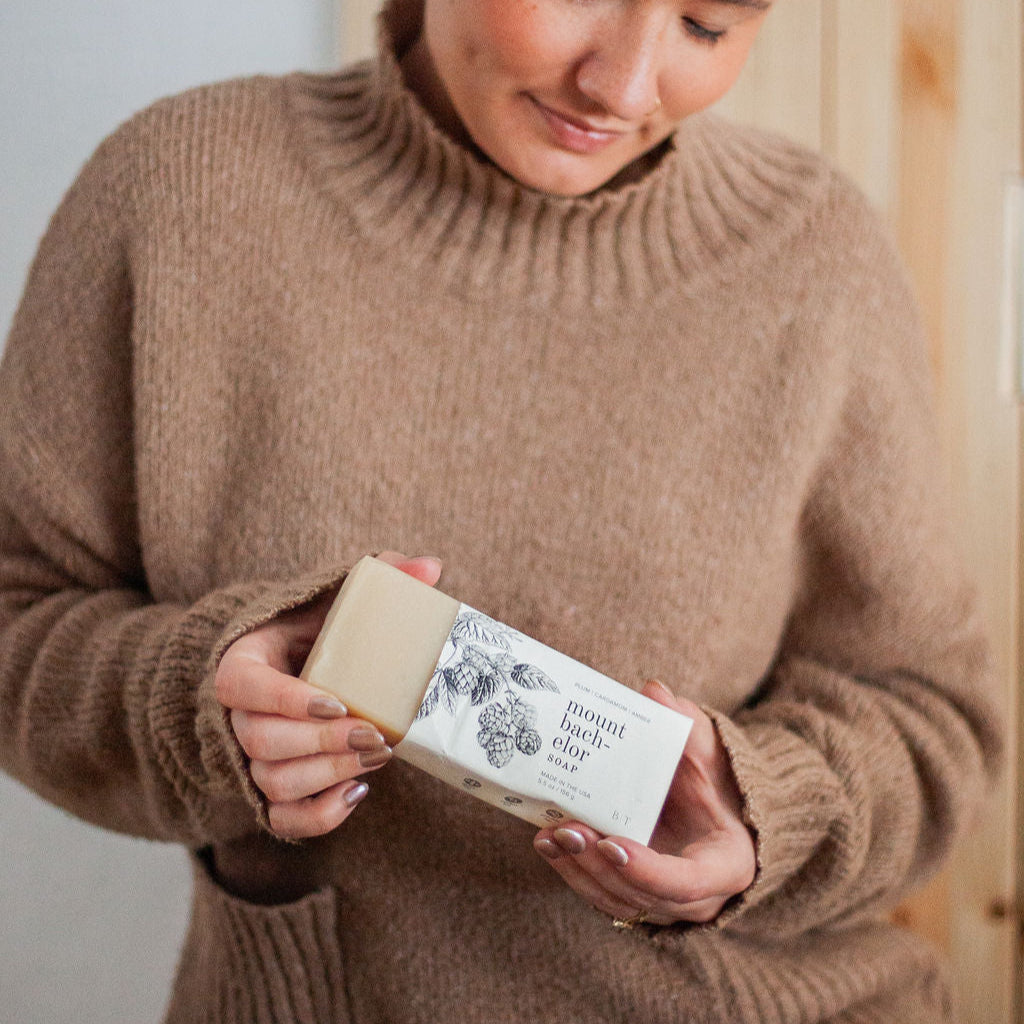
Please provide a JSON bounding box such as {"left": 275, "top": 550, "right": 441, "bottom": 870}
{"left": 214, "top": 551, "right": 441, "bottom": 839}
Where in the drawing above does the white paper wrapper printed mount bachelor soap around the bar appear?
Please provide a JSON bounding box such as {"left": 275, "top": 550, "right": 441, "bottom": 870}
{"left": 394, "top": 605, "right": 693, "bottom": 844}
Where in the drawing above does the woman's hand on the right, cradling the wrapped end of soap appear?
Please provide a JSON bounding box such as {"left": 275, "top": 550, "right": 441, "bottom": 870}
{"left": 534, "top": 682, "right": 757, "bottom": 925}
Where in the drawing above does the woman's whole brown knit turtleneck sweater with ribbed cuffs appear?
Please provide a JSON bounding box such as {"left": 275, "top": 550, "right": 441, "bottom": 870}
{"left": 0, "top": 4, "right": 999, "bottom": 1024}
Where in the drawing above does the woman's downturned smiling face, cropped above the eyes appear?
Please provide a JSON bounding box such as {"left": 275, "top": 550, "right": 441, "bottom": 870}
{"left": 411, "top": 0, "right": 771, "bottom": 196}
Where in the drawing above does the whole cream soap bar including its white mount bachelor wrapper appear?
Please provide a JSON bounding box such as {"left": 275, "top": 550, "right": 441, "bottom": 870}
{"left": 301, "top": 558, "right": 692, "bottom": 843}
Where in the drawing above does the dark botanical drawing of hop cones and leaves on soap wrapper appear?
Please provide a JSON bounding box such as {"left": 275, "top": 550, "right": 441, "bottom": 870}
{"left": 417, "top": 611, "right": 558, "bottom": 768}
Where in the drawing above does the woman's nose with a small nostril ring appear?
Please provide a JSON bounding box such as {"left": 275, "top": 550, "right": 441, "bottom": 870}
{"left": 575, "top": 4, "right": 670, "bottom": 121}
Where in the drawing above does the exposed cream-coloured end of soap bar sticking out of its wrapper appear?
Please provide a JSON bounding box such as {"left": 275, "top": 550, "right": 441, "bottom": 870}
{"left": 301, "top": 556, "right": 459, "bottom": 744}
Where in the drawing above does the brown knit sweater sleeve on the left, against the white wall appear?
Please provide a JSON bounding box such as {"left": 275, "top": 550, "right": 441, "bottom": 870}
{"left": 0, "top": 119, "right": 337, "bottom": 845}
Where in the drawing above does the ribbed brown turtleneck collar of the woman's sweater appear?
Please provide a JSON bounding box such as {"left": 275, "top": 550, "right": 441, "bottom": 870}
{"left": 289, "top": 0, "right": 828, "bottom": 303}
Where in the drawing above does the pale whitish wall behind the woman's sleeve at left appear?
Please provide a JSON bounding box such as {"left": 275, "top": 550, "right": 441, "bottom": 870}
{"left": 0, "top": 0, "right": 337, "bottom": 1024}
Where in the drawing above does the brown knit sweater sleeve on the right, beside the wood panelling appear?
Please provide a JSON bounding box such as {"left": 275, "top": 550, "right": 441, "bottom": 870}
{"left": 713, "top": 192, "right": 1001, "bottom": 935}
